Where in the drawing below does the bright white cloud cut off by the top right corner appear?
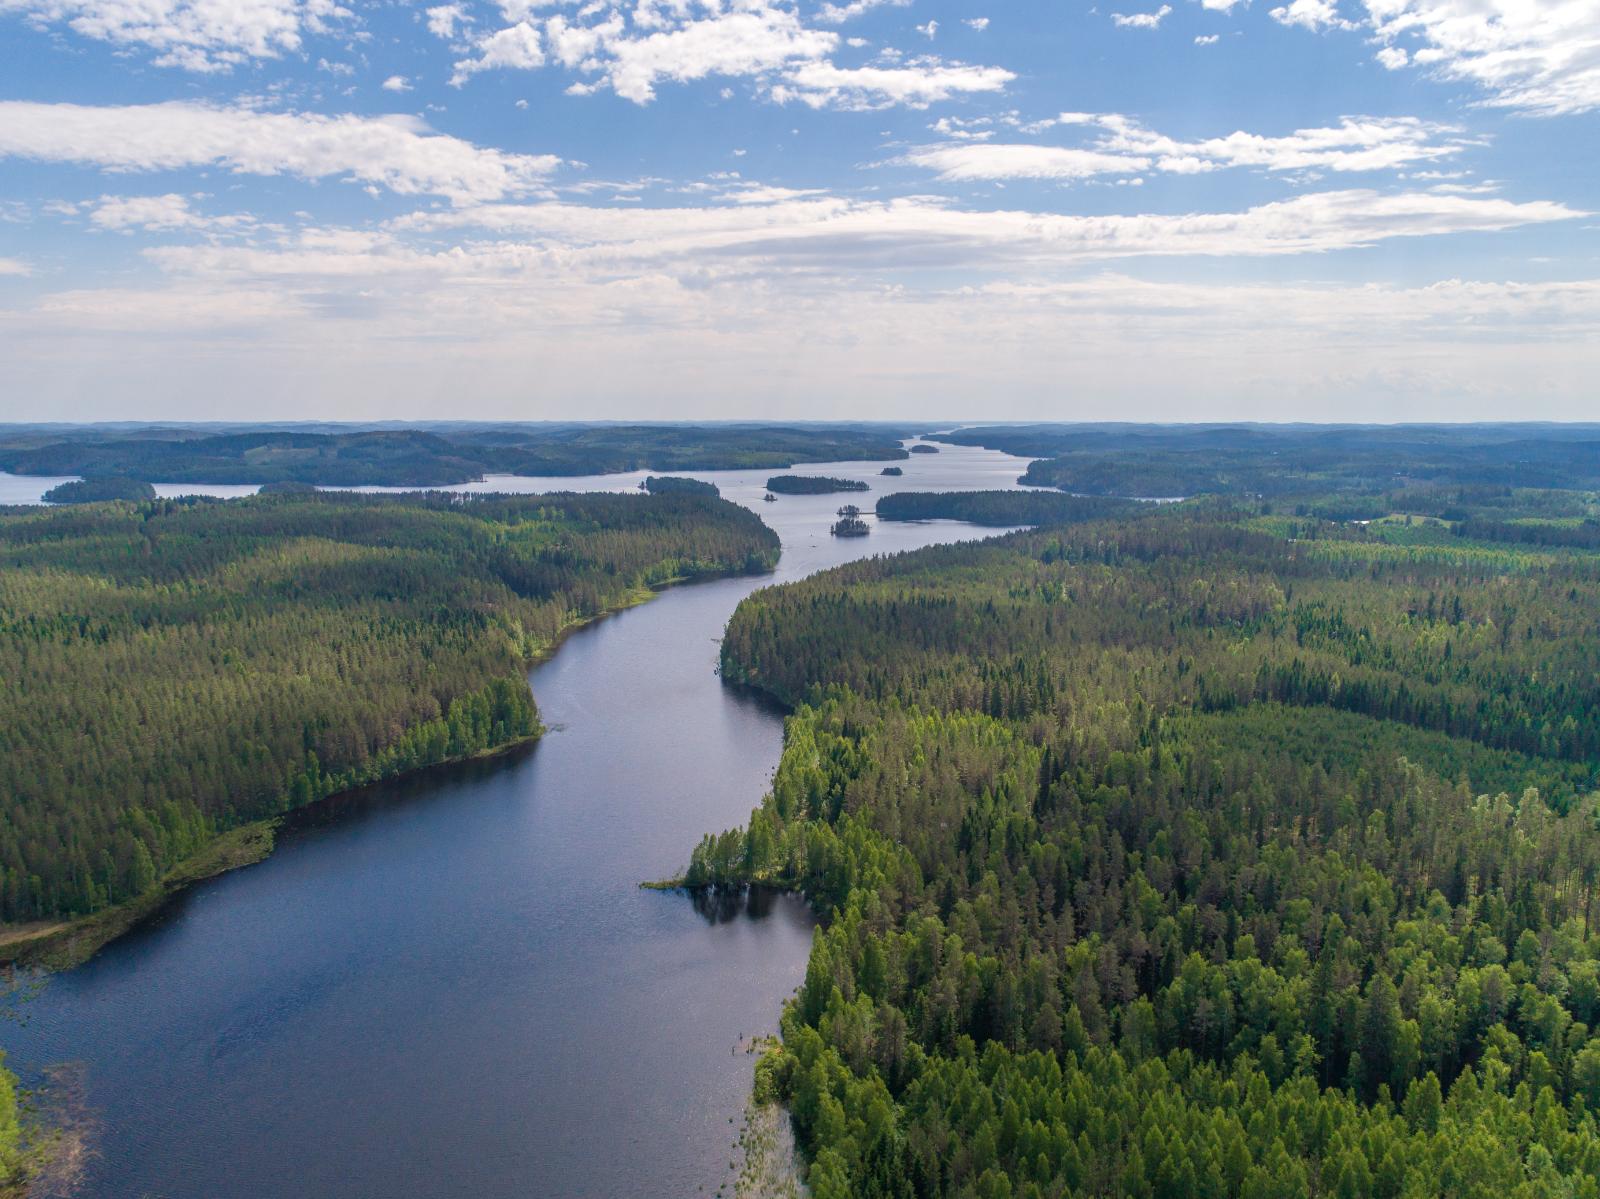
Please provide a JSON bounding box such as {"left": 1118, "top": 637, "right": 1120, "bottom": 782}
{"left": 1365, "top": 0, "right": 1600, "bottom": 115}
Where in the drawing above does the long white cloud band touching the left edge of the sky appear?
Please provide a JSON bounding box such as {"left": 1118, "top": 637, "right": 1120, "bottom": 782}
{"left": 0, "top": 101, "right": 560, "bottom": 203}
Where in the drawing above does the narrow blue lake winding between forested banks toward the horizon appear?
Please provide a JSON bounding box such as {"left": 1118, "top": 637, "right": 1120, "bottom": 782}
{"left": 0, "top": 447, "right": 1026, "bottom": 1199}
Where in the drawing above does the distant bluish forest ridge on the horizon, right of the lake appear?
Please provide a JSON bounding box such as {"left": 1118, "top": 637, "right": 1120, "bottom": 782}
{"left": 939, "top": 424, "right": 1600, "bottom": 498}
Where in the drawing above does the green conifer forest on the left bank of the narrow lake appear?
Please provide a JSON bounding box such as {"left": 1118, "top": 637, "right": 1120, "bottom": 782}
{"left": 0, "top": 493, "right": 778, "bottom": 922}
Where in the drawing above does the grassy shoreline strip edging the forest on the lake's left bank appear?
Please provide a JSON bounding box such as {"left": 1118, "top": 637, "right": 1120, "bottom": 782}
{"left": 0, "top": 550, "right": 773, "bottom": 973}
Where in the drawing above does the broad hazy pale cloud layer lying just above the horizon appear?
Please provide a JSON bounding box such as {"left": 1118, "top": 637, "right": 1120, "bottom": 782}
{"left": 9, "top": 235, "right": 1600, "bottom": 419}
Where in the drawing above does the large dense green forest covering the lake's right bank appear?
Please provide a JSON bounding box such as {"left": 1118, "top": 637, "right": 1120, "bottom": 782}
{"left": 685, "top": 480, "right": 1600, "bottom": 1199}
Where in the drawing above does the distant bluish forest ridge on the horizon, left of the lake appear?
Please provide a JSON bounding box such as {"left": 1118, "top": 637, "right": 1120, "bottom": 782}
{"left": 0, "top": 423, "right": 906, "bottom": 487}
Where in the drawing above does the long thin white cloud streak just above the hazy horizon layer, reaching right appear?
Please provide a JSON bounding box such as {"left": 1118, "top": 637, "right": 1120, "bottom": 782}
{"left": 384, "top": 189, "right": 1584, "bottom": 274}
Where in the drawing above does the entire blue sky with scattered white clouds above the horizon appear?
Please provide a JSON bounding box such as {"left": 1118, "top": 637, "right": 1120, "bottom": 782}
{"left": 0, "top": 0, "right": 1600, "bottom": 421}
